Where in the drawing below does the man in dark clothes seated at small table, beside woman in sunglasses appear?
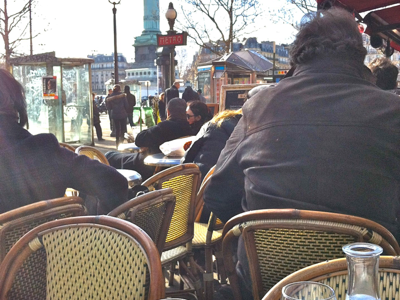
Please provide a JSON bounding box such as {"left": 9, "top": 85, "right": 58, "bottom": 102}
{"left": 106, "top": 98, "right": 191, "bottom": 180}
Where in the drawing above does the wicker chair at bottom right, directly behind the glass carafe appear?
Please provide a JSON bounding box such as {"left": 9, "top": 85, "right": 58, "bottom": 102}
{"left": 262, "top": 256, "right": 400, "bottom": 300}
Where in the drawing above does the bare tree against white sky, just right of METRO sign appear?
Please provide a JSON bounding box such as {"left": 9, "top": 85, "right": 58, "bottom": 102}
{"left": 180, "top": 0, "right": 262, "bottom": 54}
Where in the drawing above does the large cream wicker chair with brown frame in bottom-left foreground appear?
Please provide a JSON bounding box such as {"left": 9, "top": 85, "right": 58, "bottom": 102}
{"left": 0, "top": 216, "right": 165, "bottom": 300}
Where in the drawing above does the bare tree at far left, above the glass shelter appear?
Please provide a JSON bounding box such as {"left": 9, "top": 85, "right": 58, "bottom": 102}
{"left": 0, "top": 0, "right": 39, "bottom": 69}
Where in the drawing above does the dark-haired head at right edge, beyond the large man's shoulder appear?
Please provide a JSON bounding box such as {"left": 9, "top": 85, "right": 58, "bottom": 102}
{"left": 369, "top": 58, "right": 399, "bottom": 90}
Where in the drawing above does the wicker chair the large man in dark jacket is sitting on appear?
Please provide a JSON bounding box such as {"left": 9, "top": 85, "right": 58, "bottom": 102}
{"left": 222, "top": 209, "right": 400, "bottom": 300}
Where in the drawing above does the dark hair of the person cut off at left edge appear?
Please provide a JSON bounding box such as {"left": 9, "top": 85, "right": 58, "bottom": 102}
{"left": 0, "top": 69, "right": 28, "bottom": 126}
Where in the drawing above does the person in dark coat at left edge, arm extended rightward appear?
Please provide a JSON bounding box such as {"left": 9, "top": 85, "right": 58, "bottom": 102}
{"left": 0, "top": 69, "right": 128, "bottom": 213}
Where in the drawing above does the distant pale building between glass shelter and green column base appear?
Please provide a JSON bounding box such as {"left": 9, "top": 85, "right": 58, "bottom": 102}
{"left": 88, "top": 53, "right": 129, "bottom": 95}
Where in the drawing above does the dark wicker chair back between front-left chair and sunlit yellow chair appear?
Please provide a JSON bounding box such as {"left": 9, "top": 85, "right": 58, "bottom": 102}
{"left": 108, "top": 189, "right": 175, "bottom": 255}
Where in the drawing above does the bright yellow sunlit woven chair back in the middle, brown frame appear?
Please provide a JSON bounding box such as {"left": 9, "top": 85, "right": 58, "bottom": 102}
{"left": 142, "top": 164, "right": 201, "bottom": 250}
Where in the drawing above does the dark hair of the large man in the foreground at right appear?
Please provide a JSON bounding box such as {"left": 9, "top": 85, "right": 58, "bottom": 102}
{"left": 290, "top": 7, "right": 367, "bottom": 66}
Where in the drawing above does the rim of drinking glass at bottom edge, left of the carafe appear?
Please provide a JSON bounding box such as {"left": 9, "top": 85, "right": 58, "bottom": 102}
{"left": 281, "top": 281, "right": 336, "bottom": 300}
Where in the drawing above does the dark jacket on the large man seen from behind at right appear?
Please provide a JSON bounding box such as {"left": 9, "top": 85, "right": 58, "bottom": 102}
{"left": 204, "top": 58, "right": 400, "bottom": 236}
